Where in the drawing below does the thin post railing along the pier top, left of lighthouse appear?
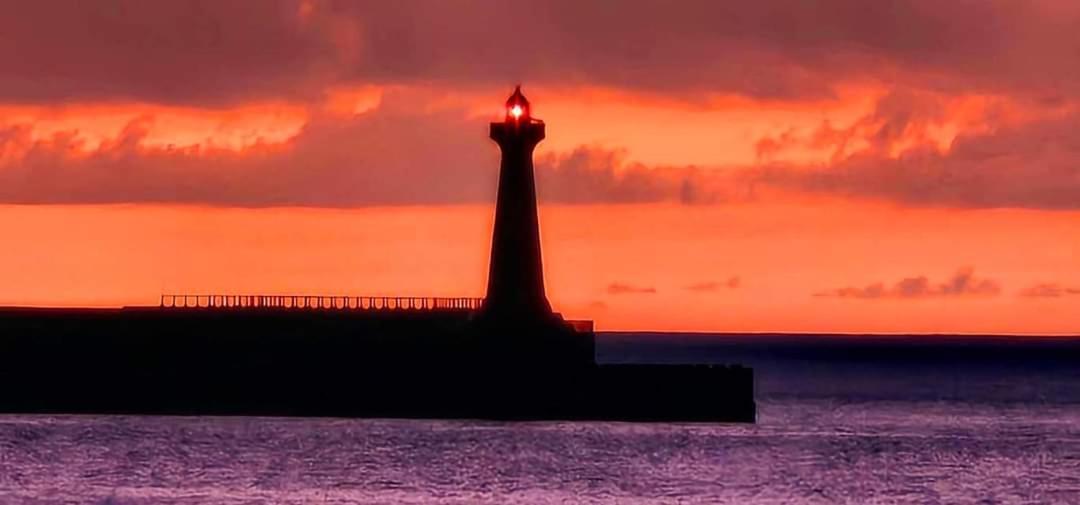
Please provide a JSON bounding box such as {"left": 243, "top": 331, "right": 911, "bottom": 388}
{"left": 161, "top": 295, "right": 484, "bottom": 311}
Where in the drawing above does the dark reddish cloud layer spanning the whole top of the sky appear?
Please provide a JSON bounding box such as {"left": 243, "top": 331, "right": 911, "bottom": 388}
{"left": 0, "top": 0, "right": 1080, "bottom": 104}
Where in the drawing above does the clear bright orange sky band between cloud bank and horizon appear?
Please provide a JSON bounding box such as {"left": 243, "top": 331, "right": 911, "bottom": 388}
{"left": 0, "top": 201, "right": 1080, "bottom": 333}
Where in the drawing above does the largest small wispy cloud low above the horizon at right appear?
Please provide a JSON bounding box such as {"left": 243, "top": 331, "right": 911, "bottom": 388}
{"left": 813, "top": 268, "right": 1001, "bottom": 300}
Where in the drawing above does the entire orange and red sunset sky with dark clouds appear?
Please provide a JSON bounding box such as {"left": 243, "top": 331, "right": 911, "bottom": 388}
{"left": 0, "top": 0, "right": 1080, "bottom": 335}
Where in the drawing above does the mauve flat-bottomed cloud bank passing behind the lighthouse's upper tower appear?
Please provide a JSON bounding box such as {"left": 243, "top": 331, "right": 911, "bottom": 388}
{"left": 0, "top": 88, "right": 725, "bottom": 207}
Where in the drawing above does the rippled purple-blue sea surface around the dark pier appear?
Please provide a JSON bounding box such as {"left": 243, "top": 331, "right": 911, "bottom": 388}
{"left": 0, "top": 333, "right": 1080, "bottom": 504}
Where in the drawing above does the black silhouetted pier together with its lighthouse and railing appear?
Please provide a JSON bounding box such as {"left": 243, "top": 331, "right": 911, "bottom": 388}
{"left": 0, "top": 87, "right": 756, "bottom": 422}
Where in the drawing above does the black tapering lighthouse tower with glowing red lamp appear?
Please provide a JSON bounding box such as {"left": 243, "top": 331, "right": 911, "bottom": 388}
{"left": 483, "top": 86, "right": 553, "bottom": 326}
